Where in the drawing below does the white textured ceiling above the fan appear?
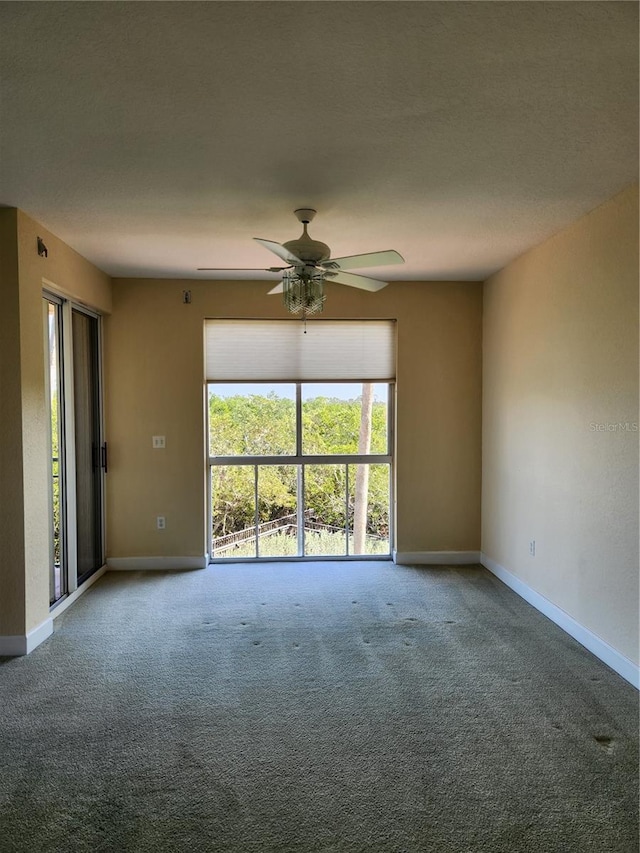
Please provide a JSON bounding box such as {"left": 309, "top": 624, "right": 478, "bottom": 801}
{"left": 0, "top": 0, "right": 638, "bottom": 280}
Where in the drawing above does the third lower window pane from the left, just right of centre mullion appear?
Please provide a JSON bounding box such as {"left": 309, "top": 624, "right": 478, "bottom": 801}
{"left": 304, "top": 465, "right": 347, "bottom": 557}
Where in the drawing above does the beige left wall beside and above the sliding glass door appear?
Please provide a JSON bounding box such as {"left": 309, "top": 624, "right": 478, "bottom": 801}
{"left": 0, "top": 209, "right": 111, "bottom": 636}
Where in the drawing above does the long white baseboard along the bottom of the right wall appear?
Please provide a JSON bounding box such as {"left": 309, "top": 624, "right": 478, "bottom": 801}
{"left": 480, "top": 553, "right": 640, "bottom": 689}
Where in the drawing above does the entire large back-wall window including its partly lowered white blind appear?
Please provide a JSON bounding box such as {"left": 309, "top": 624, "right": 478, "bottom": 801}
{"left": 205, "top": 320, "right": 395, "bottom": 560}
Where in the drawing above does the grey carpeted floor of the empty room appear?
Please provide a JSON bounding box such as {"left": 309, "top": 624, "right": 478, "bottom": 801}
{"left": 0, "top": 562, "right": 638, "bottom": 853}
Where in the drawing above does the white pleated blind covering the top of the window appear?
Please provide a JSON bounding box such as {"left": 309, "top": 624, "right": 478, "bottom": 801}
{"left": 205, "top": 320, "right": 396, "bottom": 382}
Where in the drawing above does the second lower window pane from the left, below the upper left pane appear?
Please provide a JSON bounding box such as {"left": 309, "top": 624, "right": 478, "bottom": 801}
{"left": 258, "top": 465, "right": 300, "bottom": 557}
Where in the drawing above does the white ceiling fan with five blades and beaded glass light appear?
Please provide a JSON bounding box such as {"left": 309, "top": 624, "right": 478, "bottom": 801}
{"left": 198, "top": 207, "right": 404, "bottom": 317}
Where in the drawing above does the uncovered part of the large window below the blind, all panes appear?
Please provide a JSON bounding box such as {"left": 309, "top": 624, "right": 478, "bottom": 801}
{"left": 208, "top": 382, "right": 393, "bottom": 559}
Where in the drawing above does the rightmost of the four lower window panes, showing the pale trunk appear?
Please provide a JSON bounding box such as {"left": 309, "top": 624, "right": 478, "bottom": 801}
{"left": 349, "top": 464, "right": 390, "bottom": 554}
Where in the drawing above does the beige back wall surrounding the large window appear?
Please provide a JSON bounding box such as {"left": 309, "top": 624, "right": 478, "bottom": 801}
{"left": 105, "top": 279, "right": 482, "bottom": 558}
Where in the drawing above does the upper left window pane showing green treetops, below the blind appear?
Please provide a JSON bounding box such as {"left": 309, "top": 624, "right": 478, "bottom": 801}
{"left": 209, "top": 383, "right": 296, "bottom": 456}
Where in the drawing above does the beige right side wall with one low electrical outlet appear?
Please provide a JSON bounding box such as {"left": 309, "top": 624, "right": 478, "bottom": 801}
{"left": 482, "top": 185, "right": 639, "bottom": 662}
